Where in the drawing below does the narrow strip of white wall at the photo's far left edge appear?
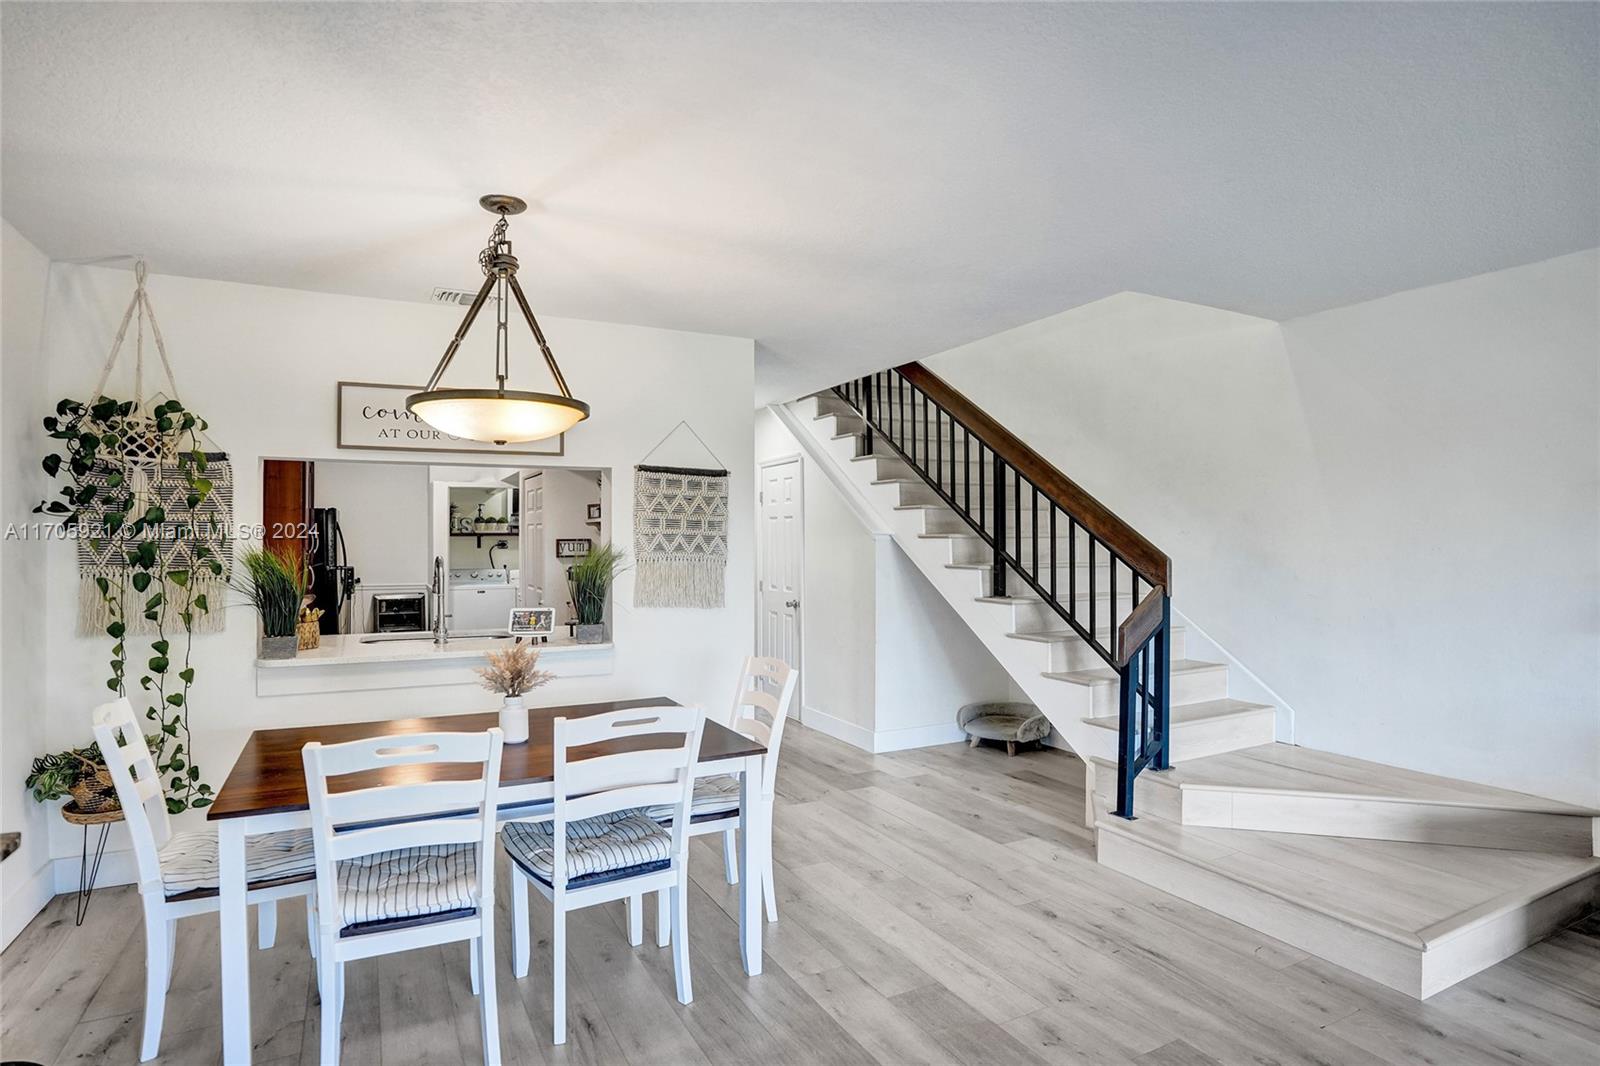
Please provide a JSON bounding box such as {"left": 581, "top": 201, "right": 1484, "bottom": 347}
{"left": 0, "top": 222, "right": 56, "bottom": 946}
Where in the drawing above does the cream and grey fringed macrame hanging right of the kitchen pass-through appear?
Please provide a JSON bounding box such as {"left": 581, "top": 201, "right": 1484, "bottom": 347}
{"left": 634, "top": 421, "right": 728, "bottom": 608}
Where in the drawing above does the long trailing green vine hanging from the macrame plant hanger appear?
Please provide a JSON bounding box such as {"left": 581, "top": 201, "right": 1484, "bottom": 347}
{"left": 34, "top": 397, "right": 224, "bottom": 813}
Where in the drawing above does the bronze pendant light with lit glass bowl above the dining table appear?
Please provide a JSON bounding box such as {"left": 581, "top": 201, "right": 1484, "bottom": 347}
{"left": 405, "top": 195, "right": 589, "bottom": 445}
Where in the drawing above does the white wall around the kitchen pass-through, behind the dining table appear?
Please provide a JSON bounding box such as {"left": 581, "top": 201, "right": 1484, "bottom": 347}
{"left": 31, "top": 264, "right": 755, "bottom": 877}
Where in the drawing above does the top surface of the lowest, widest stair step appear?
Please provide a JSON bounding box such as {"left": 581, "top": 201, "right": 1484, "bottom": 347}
{"left": 1098, "top": 813, "right": 1600, "bottom": 949}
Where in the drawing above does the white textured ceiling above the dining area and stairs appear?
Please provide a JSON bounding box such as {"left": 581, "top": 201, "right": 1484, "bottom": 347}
{"left": 0, "top": 3, "right": 1600, "bottom": 400}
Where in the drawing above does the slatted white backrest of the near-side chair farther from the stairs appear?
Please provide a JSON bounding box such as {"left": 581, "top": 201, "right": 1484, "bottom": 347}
{"left": 301, "top": 728, "right": 501, "bottom": 922}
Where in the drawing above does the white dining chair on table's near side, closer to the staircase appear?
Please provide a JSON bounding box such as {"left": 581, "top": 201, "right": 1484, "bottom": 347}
{"left": 501, "top": 706, "right": 704, "bottom": 1044}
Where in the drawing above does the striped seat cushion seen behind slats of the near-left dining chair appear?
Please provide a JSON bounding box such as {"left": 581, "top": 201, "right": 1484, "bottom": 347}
{"left": 338, "top": 844, "right": 478, "bottom": 927}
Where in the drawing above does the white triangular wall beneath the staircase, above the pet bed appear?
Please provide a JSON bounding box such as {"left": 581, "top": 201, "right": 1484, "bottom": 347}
{"left": 755, "top": 408, "right": 1021, "bottom": 751}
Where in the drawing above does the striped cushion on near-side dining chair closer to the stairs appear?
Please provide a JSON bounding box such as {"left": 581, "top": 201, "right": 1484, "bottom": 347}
{"left": 501, "top": 810, "right": 672, "bottom": 885}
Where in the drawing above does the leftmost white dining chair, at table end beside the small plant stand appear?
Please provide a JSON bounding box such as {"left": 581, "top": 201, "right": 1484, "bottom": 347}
{"left": 93, "top": 696, "right": 314, "bottom": 1063}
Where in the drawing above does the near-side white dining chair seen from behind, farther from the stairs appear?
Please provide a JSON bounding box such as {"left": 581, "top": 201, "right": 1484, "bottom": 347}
{"left": 301, "top": 728, "right": 502, "bottom": 1066}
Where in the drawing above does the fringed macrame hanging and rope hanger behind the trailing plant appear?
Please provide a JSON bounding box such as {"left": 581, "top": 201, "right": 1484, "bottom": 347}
{"left": 77, "top": 261, "right": 234, "bottom": 635}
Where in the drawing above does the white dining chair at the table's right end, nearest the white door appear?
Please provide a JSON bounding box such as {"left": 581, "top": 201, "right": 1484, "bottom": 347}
{"left": 635, "top": 655, "right": 800, "bottom": 948}
